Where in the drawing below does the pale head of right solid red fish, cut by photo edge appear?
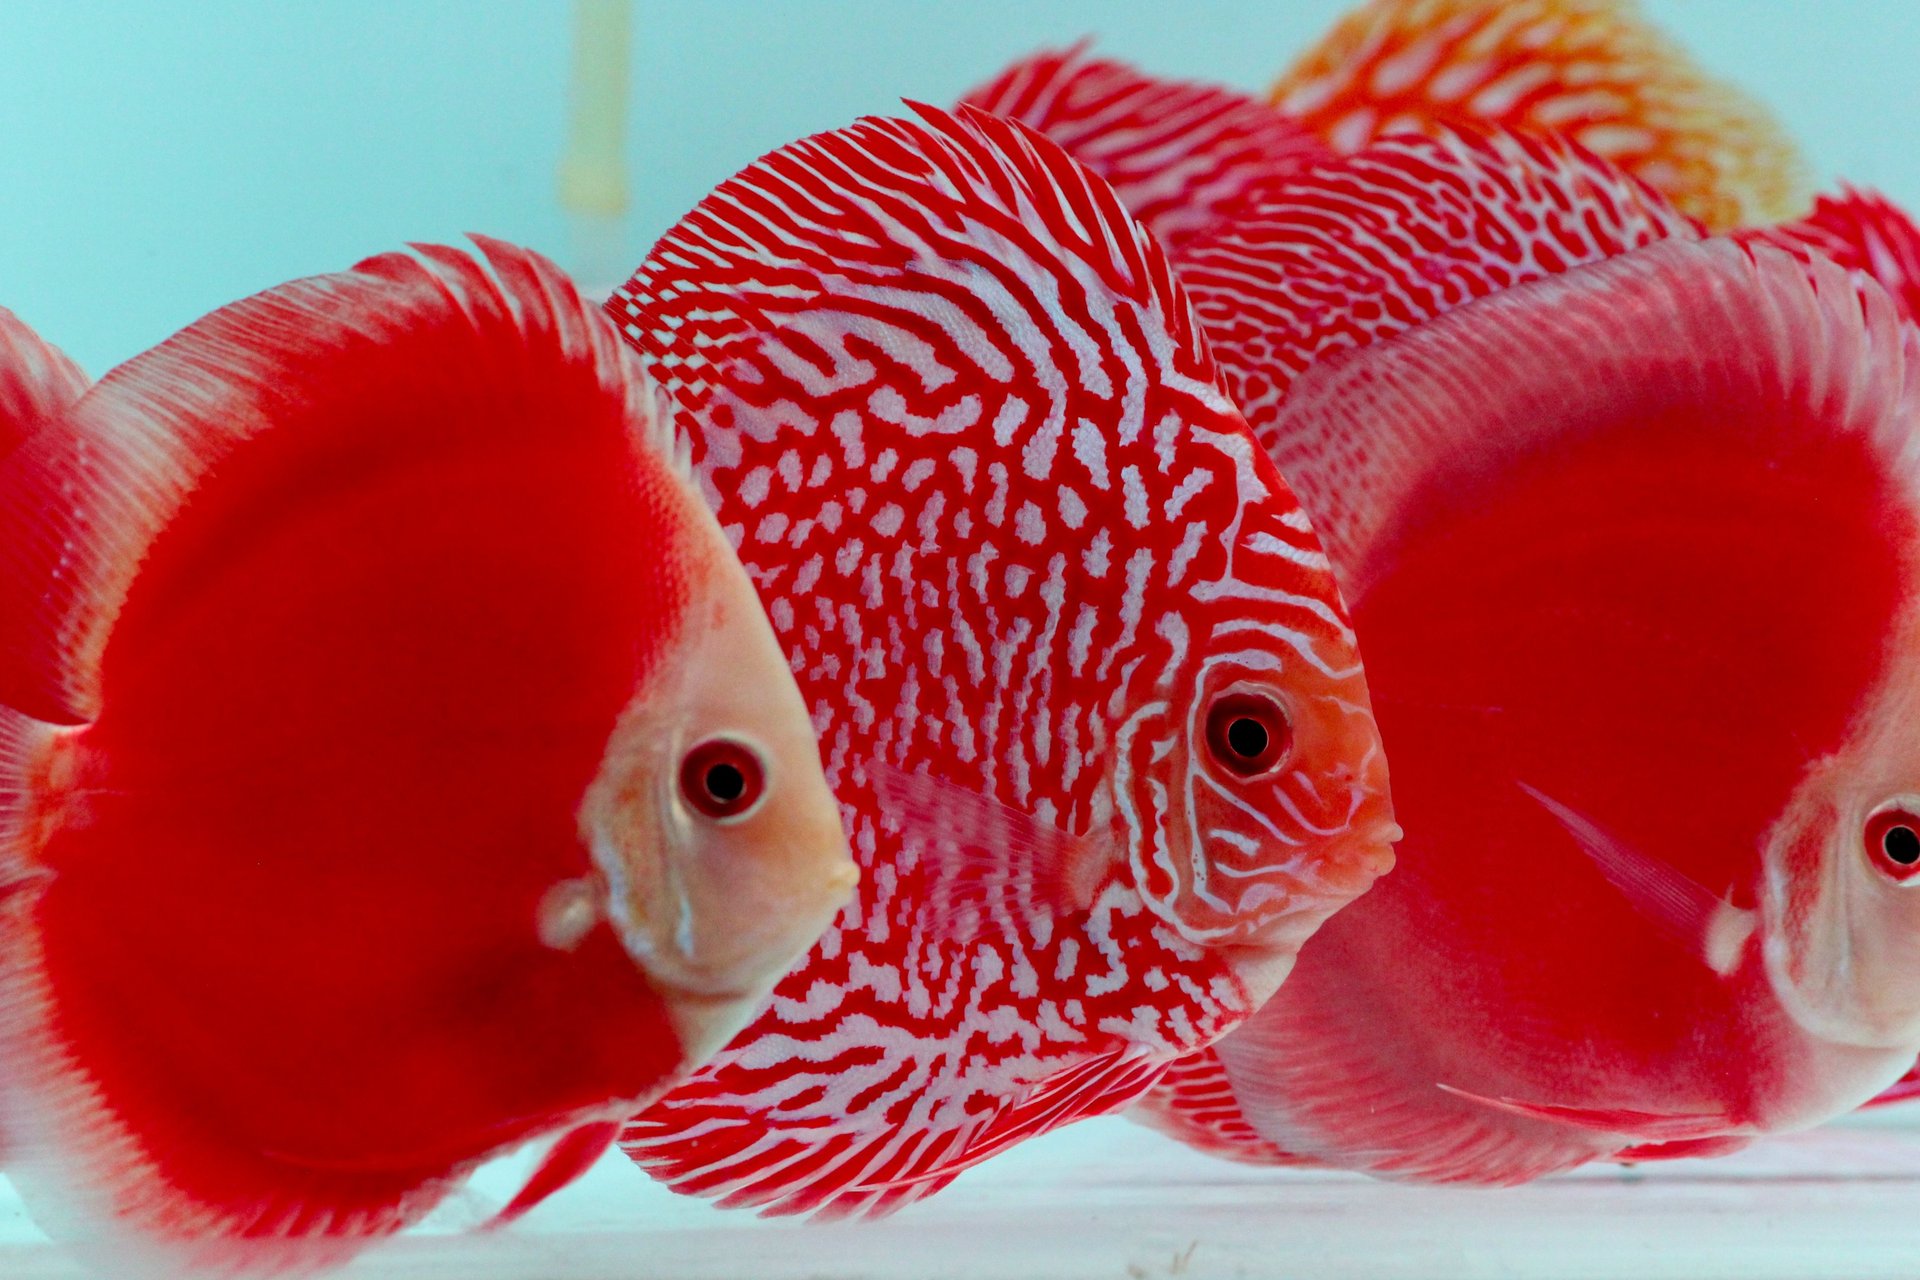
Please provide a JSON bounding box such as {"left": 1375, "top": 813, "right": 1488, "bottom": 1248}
{"left": 1761, "top": 660, "right": 1920, "bottom": 1052}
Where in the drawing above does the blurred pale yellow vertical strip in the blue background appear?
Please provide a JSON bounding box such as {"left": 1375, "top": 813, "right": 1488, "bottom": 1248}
{"left": 559, "top": 0, "right": 634, "bottom": 290}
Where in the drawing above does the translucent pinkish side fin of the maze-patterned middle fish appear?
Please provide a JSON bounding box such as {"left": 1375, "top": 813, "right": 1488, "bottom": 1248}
{"left": 866, "top": 762, "right": 1117, "bottom": 940}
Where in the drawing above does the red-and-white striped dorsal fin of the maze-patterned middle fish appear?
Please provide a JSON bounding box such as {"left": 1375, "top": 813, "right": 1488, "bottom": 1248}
{"left": 607, "top": 104, "right": 1213, "bottom": 435}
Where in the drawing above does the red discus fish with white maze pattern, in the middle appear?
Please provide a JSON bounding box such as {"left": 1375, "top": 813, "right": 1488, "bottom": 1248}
{"left": 609, "top": 107, "right": 1396, "bottom": 1213}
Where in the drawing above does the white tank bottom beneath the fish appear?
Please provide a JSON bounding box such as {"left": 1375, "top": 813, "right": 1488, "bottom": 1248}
{"left": 0, "top": 1117, "right": 1920, "bottom": 1280}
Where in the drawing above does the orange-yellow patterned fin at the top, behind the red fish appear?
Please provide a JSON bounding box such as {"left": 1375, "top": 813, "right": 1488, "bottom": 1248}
{"left": 1273, "top": 0, "right": 1807, "bottom": 230}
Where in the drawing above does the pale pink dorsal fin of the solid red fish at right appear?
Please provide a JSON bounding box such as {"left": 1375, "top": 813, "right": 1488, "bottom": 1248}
{"left": 1256, "top": 240, "right": 1920, "bottom": 579}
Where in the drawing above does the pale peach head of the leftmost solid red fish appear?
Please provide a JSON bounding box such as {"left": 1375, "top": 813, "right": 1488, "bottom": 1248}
{"left": 568, "top": 460, "right": 858, "bottom": 1063}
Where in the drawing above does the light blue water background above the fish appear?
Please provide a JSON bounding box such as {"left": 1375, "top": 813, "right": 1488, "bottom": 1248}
{"left": 0, "top": 0, "right": 1920, "bottom": 374}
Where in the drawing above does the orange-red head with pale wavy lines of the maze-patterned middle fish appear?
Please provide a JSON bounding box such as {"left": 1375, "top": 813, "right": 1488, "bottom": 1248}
{"left": 1116, "top": 420, "right": 1400, "bottom": 1004}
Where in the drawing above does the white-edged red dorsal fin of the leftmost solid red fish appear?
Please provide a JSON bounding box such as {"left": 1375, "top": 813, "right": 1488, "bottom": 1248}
{"left": 0, "top": 238, "right": 670, "bottom": 722}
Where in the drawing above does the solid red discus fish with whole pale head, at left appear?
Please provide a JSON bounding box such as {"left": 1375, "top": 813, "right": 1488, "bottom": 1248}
{"left": 0, "top": 242, "right": 856, "bottom": 1274}
